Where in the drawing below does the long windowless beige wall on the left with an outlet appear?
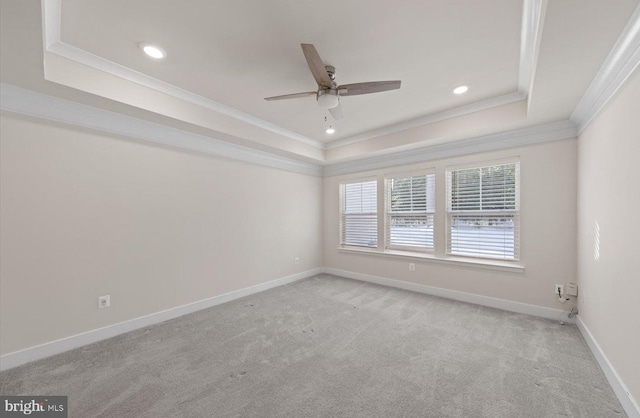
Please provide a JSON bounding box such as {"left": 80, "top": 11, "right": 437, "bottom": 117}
{"left": 0, "top": 113, "right": 322, "bottom": 354}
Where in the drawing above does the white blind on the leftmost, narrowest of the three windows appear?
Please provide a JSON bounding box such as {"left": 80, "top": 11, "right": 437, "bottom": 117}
{"left": 340, "top": 180, "right": 378, "bottom": 247}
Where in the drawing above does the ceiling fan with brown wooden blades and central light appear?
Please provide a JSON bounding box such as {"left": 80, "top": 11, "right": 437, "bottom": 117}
{"left": 265, "top": 44, "right": 400, "bottom": 119}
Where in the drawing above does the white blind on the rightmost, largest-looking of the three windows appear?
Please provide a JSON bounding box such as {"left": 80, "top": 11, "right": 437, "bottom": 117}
{"left": 447, "top": 162, "right": 520, "bottom": 260}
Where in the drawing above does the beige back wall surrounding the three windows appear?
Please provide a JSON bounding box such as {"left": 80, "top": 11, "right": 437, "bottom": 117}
{"left": 324, "top": 139, "right": 576, "bottom": 309}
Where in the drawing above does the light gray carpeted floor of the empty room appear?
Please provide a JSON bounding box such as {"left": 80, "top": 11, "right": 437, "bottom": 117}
{"left": 0, "top": 275, "right": 626, "bottom": 418}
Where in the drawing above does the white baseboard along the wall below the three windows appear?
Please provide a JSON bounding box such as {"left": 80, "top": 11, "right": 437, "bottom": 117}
{"left": 324, "top": 267, "right": 574, "bottom": 323}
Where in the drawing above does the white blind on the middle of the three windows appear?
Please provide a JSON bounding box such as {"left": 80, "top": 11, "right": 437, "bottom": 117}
{"left": 385, "top": 173, "right": 435, "bottom": 250}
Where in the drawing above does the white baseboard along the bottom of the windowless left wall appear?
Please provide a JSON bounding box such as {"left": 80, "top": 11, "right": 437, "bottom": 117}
{"left": 0, "top": 268, "right": 323, "bottom": 370}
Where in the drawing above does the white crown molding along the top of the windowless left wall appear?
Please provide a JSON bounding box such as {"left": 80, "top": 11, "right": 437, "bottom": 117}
{"left": 0, "top": 84, "right": 322, "bottom": 176}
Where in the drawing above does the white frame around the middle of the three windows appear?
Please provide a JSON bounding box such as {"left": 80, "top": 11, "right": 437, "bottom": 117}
{"left": 383, "top": 168, "right": 437, "bottom": 254}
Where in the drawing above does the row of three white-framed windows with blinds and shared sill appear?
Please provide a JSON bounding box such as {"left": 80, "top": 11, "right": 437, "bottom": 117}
{"left": 340, "top": 157, "right": 524, "bottom": 271}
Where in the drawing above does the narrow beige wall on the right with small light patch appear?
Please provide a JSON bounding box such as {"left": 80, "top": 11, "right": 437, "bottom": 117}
{"left": 578, "top": 71, "right": 640, "bottom": 401}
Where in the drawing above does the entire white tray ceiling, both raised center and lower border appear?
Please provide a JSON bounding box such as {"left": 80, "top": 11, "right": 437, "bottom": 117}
{"left": 0, "top": 0, "right": 640, "bottom": 163}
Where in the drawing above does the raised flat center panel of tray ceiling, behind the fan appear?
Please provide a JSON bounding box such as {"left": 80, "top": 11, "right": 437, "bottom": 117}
{"left": 61, "top": 0, "right": 522, "bottom": 141}
